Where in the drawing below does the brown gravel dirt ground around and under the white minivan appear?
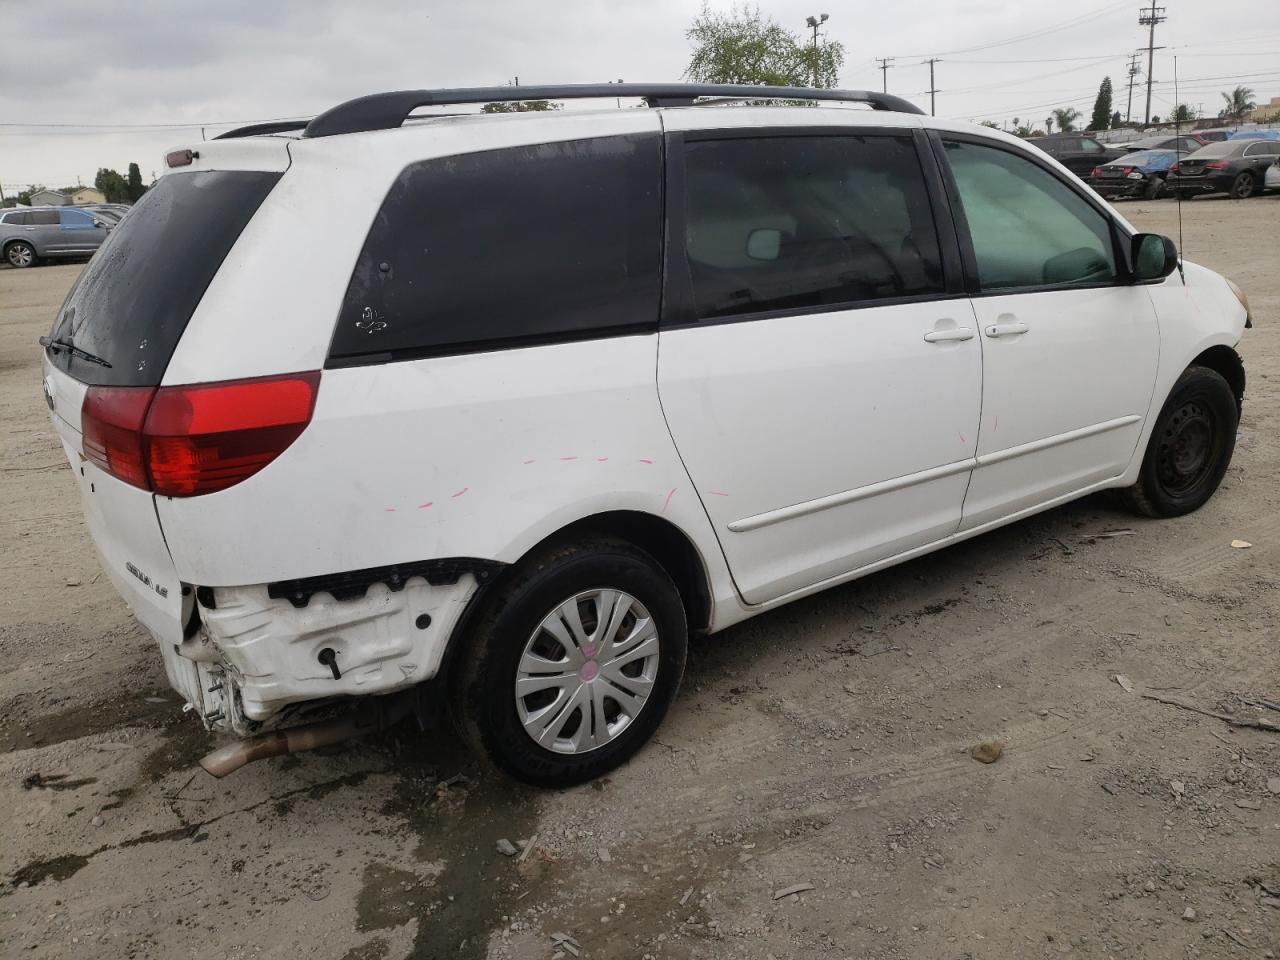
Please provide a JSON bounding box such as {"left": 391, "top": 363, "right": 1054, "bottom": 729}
{"left": 0, "top": 196, "right": 1280, "bottom": 960}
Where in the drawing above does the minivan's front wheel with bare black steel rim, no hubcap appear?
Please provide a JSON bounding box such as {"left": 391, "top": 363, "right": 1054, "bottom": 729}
{"left": 1124, "top": 366, "right": 1240, "bottom": 517}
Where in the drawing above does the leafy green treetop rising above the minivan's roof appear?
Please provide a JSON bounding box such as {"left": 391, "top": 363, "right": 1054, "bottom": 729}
{"left": 685, "top": 6, "right": 845, "bottom": 87}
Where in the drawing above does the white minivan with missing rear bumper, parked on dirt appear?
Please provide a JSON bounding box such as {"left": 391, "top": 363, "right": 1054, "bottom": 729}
{"left": 42, "top": 84, "right": 1249, "bottom": 786}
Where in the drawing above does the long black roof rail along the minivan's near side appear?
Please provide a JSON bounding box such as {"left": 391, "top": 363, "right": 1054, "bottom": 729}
{"left": 299, "top": 83, "right": 924, "bottom": 137}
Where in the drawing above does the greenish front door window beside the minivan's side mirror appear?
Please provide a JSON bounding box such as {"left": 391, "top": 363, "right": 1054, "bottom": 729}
{"left": 946, "top": 142, "right": 1116, "bottom": 291}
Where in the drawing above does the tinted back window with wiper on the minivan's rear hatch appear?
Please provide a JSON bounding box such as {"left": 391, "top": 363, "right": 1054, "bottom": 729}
{"left": 50, "top": 170, "right": 282, "bottom": 385}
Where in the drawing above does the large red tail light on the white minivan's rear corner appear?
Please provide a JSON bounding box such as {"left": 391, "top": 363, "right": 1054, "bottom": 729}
{"left": 81, "top": 370, "right": 320, "bottom": 497}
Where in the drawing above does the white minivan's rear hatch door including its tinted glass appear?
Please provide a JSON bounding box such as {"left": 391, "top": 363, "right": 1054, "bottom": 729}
{"left": 44, "top": 141, "right": 288, "bottom": 703}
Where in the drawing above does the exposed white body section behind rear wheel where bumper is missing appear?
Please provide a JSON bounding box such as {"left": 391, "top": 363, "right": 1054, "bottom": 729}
{"left": 166, "top": 559, "right": 500, "bottom": 736}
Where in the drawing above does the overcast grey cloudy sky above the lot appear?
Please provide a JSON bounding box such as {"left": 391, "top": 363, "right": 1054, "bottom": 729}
{"left": 0, "top": 0, "right": 1280, "bottom": 192}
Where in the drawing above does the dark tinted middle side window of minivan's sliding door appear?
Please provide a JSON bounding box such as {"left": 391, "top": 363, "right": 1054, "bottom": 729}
{"left": 685, "top": 136, "right": 943, "bottom": 319}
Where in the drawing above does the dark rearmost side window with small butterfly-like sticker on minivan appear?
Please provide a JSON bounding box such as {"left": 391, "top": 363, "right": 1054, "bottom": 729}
{"left": 330, "top": 134, "right": 662, "bottom": 361}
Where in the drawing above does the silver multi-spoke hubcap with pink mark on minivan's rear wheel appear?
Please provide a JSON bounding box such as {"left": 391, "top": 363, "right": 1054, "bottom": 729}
{"left": 516, "top": 590, "right": 658, "bottom": 754}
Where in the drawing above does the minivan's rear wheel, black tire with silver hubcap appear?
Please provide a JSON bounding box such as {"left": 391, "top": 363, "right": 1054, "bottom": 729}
{"left": 449, "top": 539, "right": 689, "bottom": 787}
